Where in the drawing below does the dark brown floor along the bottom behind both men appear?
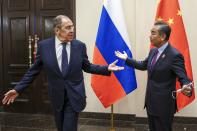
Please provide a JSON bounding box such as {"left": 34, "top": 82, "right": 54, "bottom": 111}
{"left": 0, "top": 113, "right": 197, "bottom": 131}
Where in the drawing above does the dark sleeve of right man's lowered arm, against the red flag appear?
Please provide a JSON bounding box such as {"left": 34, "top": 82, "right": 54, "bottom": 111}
{"left": 172, "top": 54, "right": 191, "bottom": 86}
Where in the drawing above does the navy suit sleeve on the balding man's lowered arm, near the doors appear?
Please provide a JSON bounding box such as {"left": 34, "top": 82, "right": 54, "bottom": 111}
{"left": 14, "top": 44, "right": 42, "bottom": 93}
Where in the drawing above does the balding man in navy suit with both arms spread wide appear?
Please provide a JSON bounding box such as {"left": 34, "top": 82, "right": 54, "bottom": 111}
{"left": 2, "top": 15, "right": 124, "bottom": 131}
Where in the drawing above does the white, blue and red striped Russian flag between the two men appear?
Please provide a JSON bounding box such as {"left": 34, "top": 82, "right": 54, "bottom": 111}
{"left": 91, "top": 0, "right": 137, "bottom": 108}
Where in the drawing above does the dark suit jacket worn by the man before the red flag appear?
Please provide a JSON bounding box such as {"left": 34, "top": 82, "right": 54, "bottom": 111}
{"left": 126, "top": 44, "right": 190, "bottom": 116}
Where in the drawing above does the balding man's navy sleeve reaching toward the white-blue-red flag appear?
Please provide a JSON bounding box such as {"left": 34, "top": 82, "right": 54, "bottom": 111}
{"left": 82, "top": 44, "right": 111, "bottom": 76}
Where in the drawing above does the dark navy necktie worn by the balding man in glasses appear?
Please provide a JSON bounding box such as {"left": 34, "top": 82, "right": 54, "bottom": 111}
{"left": 62, "top": 43, "right": 68, "bottom": 76}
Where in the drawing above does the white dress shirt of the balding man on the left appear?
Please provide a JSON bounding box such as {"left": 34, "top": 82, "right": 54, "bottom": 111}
{"left": 55, "top": 36, "right": 71, "bottom": 71}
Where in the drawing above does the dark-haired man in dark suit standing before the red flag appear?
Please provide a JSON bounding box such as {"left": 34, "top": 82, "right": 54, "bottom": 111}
{"left": 115, "top": 21, "right": 191, "bottom": 131}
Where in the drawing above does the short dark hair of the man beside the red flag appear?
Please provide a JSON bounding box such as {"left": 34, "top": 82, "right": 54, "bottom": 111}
{"left": 154, "top": 20, "right": 171, "bottom": 41}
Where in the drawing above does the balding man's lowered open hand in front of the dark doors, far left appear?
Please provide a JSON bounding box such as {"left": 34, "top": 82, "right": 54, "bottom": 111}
{"left": 2, "top": 89, "right": 19, "bottom": 105}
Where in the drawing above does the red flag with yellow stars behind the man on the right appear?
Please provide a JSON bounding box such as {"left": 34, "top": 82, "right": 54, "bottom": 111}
{"left": 156, "top": 0, "right": 195, "bottom": 111}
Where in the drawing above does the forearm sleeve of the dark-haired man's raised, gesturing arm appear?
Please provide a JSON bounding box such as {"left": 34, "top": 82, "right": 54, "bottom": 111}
{"left": 125, "top": 58, "right": 148, "bottom": 70}
